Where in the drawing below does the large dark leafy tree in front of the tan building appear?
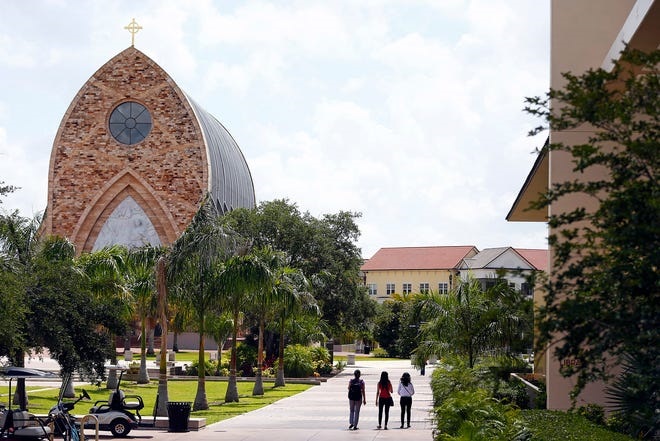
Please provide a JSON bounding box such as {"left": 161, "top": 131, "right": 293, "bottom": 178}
{"left": 526, "top": 46, "right": 660, "bottom": 400}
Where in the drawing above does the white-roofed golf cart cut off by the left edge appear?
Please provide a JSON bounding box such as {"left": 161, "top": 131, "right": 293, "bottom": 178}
{"left": 0, "top": 366, "right": 58, "bottom": 440}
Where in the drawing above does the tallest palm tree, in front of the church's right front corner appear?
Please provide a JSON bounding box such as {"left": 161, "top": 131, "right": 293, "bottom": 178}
{"left": 167, "top": 198, "right": 237, "bottom": 411}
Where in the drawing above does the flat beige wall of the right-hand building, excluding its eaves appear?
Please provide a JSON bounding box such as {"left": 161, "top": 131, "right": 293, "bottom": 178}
{"left": 545, "top": 0, "right": 635, "bottom": 409}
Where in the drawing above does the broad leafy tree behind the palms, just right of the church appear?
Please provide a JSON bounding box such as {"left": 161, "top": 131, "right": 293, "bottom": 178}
{"left": 226, "top": 199, "right": 375, "bottom": 334}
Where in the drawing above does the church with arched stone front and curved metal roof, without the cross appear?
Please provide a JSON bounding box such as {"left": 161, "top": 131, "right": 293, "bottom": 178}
{"left": 42, "top": 46, "right": 255, "bottom": 253}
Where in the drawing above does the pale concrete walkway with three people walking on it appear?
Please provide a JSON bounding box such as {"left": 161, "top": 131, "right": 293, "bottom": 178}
{"left": 7, "top": 359, "right": 433, "bottom": 441}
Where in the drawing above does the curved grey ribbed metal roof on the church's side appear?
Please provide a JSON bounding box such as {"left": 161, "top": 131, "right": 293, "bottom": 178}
{"left": 186, "top": 96, "right": 255, "bottom": 214}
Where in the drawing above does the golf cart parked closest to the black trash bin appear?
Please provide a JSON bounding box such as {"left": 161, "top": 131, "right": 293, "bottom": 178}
{"left": 85, "top": 366, "right": 144, "bottom": 438}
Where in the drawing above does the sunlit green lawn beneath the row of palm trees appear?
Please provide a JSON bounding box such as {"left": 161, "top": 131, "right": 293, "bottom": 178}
{"left": 0, "top": 380, "right": 312, "bottom": 424}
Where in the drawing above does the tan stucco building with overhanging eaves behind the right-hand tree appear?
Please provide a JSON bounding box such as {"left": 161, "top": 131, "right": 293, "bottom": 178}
{"left": 507, "top": 0, "right": 660, "bottom": 409}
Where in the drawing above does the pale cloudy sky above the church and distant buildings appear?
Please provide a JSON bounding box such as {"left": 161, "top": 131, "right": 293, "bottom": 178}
{"left": 0, "top": 0, "right": 549, "bottom": 258}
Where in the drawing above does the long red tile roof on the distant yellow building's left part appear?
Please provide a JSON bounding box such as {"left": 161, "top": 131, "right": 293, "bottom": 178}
{"left": 361, "top": 245, "right": 478, "bottom": 271}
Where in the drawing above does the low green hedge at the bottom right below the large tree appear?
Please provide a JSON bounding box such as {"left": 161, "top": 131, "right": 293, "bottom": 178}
{"left": 520, "top": 409, "right": 634, "bottom": 441}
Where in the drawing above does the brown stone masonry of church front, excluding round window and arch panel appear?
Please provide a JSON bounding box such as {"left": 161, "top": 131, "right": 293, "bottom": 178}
{"left": 45, "top": 47, "right": 208, "bottom": 252}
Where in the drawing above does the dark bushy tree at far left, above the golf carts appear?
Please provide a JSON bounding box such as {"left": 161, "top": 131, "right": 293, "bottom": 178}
{"left": 0, "top": 212, "right": 123, "bottom": 407}
